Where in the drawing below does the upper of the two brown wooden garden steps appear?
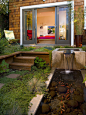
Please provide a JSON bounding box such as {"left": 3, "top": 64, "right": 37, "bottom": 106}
{"left": 13, "top": 56, "right": 36, "bottom": 64}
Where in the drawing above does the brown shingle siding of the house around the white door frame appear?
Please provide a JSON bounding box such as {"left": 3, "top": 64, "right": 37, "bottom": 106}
{"left": 9, "top": 0, "right": 84, "bottom": 39}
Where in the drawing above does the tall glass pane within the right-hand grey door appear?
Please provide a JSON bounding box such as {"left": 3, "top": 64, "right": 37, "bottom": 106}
{"left": 59, "top": 7, "right": 69, "bottom": 40}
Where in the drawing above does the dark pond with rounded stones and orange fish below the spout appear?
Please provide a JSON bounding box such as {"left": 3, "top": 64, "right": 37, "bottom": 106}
{"left": 36, "top": 69, "right": 86, "bottom": 115}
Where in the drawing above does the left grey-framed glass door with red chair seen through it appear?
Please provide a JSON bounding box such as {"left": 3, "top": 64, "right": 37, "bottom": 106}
{"left": 23, "top": 9, "right": 35, "bottom": 44}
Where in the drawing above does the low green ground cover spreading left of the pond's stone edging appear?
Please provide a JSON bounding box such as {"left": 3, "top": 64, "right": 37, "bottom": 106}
{"left": 0, "top": 66, "right": 50, "bottom": 115}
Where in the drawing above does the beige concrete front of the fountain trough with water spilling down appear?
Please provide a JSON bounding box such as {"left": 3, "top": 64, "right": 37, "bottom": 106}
{"left": 52, "top": 49, "right": 86, "bottom": 70}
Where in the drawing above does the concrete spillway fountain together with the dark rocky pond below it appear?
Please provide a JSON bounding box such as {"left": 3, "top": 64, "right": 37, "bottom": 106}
{"left": 36, "top": 49, "right": 86, "bottom": 115}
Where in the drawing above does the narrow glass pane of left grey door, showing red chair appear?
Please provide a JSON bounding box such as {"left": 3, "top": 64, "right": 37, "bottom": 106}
{"left": 24, "top": 11, "right": 32, "bottom": 41}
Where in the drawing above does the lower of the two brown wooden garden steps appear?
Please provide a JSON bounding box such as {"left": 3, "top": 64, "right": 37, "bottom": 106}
{"left": 9, "top": 62, "right": 34, "bottom": 71}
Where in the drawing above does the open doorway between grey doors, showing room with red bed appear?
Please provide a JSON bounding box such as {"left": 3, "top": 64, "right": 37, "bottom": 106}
{"left": 37, "top": 7, "right": 55, "bottom": 44}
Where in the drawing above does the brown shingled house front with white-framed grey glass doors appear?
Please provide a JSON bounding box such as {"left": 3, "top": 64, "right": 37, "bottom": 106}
{"left": 9, "top": 0, "right": 86, "bottom": 46}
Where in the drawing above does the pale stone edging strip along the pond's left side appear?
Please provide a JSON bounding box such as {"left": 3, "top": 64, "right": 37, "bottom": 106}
{"left": 28, "top": 73, "right": 53, "bottom": 115}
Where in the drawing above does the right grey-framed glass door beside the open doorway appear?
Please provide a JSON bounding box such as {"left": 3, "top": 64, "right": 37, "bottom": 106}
{"left": 56, "top": 6, "right": 71, "bottom": 45}
